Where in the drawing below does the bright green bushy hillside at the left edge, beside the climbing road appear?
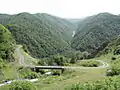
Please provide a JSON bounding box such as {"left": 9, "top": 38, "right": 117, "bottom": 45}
{"left": 0, "top": 24, "right": 15, "bottom": 60}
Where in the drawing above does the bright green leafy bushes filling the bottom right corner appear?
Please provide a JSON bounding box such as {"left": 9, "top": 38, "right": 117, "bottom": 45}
{"left": 66, "top": 76, "right": 120, "bottom": 90}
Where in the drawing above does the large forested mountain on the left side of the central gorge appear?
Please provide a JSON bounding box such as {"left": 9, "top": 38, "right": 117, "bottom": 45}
{"left": 0, "top": 13, "right": 75, "bottom": 58}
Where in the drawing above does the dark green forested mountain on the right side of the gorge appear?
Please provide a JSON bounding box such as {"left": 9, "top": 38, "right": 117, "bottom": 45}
{"left": 72, "top": 13, "right": 120, "bottom": 57}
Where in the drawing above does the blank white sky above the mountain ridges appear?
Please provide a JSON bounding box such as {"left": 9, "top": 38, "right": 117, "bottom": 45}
{"left": 0, "top": 0, "right": 120, "bottom": 18}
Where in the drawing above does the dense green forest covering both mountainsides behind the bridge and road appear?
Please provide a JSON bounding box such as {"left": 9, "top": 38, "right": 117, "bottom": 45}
{"left": 0, "top": 12, "right": 120, "bottom": 59}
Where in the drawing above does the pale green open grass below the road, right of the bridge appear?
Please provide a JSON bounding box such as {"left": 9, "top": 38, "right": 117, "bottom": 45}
{"left": 35, "top": 69, "right": 105, "bottom": 90}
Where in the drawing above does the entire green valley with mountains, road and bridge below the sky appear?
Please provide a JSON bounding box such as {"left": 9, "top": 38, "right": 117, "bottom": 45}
{"left": 0, "top": 12, "right": 120, "bottom": 90}
